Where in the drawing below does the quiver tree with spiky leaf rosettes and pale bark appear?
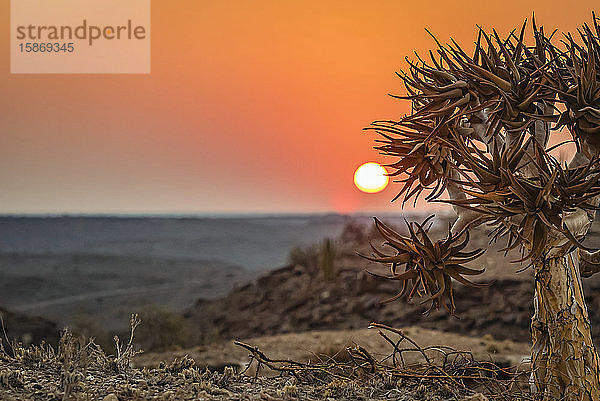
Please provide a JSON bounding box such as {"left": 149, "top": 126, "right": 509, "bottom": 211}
{"left": 368, "top": 15, "right": 600, "bottom": 401}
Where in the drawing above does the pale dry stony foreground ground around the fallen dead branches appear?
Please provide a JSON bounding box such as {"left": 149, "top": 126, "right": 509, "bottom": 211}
{"left": 0, "top": 328, "right": 528, "bottom": 401}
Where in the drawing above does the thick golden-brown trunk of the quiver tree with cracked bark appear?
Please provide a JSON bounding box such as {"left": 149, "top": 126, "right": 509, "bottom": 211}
{"left": 531, "top": 250, "right": 600, "bottom": 401}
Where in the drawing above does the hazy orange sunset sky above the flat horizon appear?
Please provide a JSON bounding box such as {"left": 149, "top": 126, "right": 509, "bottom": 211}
{"left": 0, "top": 0, "right": 599, "bottom": 213}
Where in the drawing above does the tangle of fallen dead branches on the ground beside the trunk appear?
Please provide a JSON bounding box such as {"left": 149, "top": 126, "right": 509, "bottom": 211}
{"left": 234, "top": 323, "right": 533, "bottom": 400}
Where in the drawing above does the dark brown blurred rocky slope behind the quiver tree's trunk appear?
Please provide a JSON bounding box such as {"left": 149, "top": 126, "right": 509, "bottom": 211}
{"left": 186, "top": 260, "right": 600, "bottom": 342}
